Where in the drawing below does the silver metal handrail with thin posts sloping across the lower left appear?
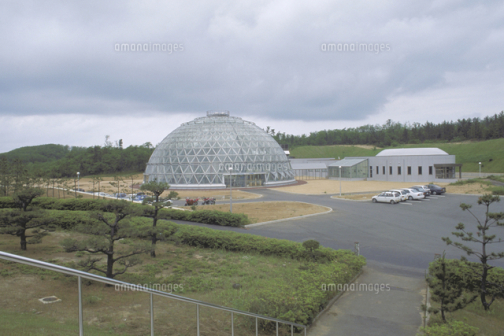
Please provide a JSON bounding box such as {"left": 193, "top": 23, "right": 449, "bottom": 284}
{"left": 0, "top": 251, "right": 307, "bottom": 336}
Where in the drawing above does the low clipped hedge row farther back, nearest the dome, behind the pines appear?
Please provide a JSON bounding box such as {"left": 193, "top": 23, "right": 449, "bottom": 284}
{"left": 0, "top": 197, "right": 250, "bottom": 227}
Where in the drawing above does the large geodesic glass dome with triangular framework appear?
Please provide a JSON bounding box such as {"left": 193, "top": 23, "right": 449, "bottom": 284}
{"left": 144, "top": 111, "right": 296, "bottom": 189}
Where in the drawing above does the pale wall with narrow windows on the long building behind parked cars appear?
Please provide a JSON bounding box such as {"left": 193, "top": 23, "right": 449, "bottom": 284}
{"left": 367, "top": 155, "right": 456, "bottom": 182}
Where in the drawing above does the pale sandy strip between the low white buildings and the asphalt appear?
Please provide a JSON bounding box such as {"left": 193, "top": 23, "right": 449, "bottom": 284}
{"left": 275, "top": 180, "right": 447, "bottom": 195}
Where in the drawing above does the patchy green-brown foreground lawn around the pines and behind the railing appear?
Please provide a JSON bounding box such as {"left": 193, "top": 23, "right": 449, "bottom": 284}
{"left": 0, "top": 224, "right": 363, "bottom": 336}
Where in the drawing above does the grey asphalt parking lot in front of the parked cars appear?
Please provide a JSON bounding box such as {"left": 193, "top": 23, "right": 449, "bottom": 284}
{"left": 172, "top": 189, "right": 504, "bottom": 273}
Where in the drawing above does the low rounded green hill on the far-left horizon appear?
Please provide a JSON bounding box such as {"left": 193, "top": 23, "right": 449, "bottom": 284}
{"left": 0, "top": 144, "right": 70, "bottom": 163}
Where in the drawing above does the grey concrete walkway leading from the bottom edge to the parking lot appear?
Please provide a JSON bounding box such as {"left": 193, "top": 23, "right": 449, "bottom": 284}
{"left": 308, "top": 264, "right": 426, "bottom": 336}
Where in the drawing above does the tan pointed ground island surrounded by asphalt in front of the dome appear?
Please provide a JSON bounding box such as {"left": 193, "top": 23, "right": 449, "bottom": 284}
{"left": 184, "top": 201, "right": 330, "bottom": 223}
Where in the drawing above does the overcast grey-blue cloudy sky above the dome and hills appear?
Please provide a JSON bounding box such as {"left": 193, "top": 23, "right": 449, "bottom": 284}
{"left": 0, "top": 0, "right": 504, "bottom": 152}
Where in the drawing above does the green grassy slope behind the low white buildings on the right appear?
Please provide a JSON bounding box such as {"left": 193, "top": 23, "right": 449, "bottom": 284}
{"left": 291, "top": 139, "right": 504, "bottom": 173}
